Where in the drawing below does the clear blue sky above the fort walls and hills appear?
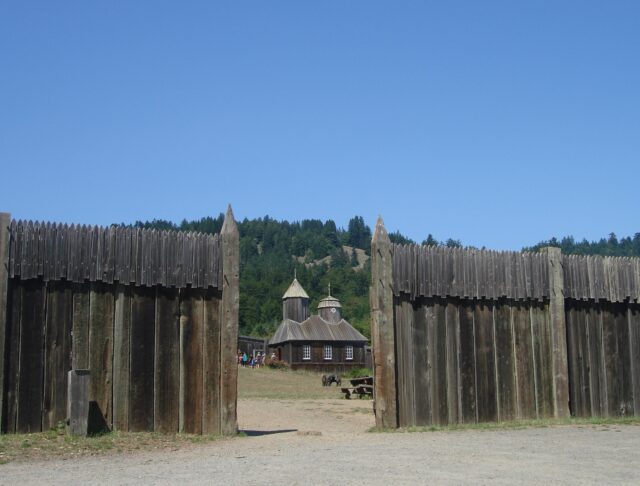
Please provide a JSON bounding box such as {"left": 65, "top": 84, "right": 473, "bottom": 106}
{"left": 0, "top": 0, "right": 640, "bottom": 249}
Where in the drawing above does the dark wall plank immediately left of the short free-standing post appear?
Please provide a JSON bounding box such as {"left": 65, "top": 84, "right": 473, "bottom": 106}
{"left": 42, "top": 282, "right": 73, "bottom": 430}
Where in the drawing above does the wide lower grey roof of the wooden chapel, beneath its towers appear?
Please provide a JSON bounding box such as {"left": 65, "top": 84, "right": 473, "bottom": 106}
{"left": 269, "top": 315, "right": 368, "bottom": 346}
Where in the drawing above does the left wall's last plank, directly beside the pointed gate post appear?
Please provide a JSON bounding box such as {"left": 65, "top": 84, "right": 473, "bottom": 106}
{"left": 205, "top": 288, "right": 222, "bottom": 435}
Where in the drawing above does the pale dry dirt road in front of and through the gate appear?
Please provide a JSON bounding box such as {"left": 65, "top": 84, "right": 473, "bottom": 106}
{"left": 0, "top": 399, "right": 640, "bottom": 486}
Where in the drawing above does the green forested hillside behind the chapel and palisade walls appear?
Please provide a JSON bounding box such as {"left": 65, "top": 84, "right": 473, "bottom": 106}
{"left": 135, "top": 214, "right": 640, "bottom": 337}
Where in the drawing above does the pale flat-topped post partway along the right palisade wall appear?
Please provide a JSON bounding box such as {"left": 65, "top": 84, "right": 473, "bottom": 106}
{"left": 545, "top": 247, "right": 570, "bottom": 418}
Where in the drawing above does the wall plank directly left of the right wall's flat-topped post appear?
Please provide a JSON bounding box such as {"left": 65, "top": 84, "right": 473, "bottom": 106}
{"left": 513, "top": 302, "right": 537, "bottom": 419}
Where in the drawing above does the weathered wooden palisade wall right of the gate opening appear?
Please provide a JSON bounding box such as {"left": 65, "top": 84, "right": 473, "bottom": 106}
{"left": 371, "top": 220, "right": 640, "bottom": 427}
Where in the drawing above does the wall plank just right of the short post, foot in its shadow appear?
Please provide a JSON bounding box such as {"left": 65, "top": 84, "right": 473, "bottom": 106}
{"left": 89, "top": 282, "right": 114, "bottom": 427}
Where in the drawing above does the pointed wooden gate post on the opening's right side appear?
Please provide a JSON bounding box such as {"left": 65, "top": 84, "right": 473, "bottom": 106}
{"left": 369, "top": 217, "right": 398, "bottom": 428}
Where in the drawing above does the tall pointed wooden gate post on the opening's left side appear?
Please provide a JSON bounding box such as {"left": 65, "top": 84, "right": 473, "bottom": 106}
{"left": 220, "top": 205, "right": 240, "bottom": 435}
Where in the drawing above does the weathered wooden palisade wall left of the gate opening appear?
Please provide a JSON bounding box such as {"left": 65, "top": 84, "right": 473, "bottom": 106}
{"left": 0, "top": 209, "right": 238, "bottom": 434}
